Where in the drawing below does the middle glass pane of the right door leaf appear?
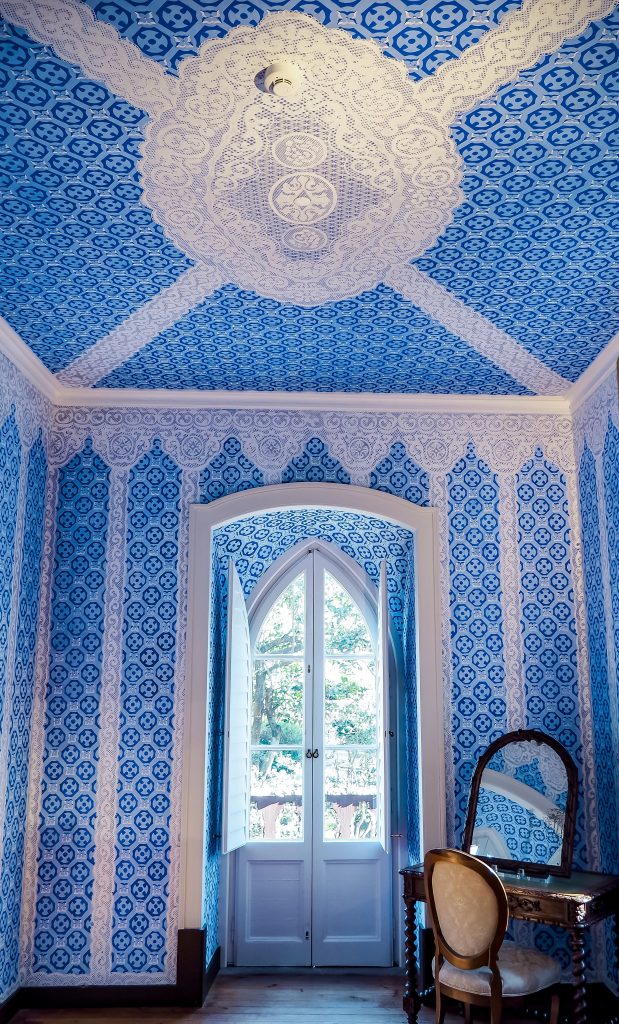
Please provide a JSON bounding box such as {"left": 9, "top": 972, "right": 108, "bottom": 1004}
{"left": 325, "top": 657, "right": 376, "bottom": 745}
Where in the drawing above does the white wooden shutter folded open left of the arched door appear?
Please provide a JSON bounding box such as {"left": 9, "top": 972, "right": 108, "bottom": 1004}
{"left": 221, "top": 558, "right": 251, "bottom": 853}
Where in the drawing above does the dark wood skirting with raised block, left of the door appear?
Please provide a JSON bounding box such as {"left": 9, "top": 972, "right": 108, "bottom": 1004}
{"left": 0, "top": 928, "right": 219, "bottom": 1024}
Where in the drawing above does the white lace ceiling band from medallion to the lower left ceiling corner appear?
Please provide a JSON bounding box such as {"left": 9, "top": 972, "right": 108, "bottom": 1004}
{"left": 57, "top": 264, "right": 223, "bottom": 387}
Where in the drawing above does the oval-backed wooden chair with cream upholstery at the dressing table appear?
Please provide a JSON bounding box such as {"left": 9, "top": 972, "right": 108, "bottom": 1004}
{"left": 423, "top": 850, "right": 561, "bottom": 1024}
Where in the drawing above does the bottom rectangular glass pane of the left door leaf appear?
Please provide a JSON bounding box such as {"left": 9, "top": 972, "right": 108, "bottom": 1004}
{"left": 249, "top": 750, "right": 303, "bottom": 840}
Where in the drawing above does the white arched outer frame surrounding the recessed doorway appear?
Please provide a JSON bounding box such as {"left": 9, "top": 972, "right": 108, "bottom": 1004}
{"left": 178, "top": 483, "right": 446, "bottom": 928}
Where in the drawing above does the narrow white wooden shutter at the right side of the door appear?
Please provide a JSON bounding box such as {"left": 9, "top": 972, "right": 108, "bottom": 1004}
{"left": 376, "top": 562, "right": 391, "bottom": 851}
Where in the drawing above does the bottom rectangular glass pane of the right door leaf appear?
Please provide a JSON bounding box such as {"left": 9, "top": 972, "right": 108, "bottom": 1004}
{"left": 325, "top": 751, "right": 378, "bottom": 841}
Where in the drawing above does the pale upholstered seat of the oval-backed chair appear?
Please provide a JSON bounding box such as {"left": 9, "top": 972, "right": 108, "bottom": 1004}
{"left": 440, "top": 942, "right": 561, "bottom": 998}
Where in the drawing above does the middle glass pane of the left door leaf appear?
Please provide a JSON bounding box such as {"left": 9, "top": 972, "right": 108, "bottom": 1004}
{"left": 251, "top": 657, "right": 304, "bottom": 744}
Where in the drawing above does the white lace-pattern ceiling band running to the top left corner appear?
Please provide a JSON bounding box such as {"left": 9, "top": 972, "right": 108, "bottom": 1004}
{"left": 0, "top": 0, "right": 176, "bottom": 114}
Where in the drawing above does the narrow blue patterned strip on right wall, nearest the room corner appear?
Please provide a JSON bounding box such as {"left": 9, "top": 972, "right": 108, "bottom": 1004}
{"left": 579, "top": 447, "right": 619, "bottom": 871}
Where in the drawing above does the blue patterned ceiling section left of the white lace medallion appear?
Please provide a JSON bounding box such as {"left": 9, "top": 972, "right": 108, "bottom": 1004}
{"left": 0, "top": 20, "right": 192, "bottom": 372}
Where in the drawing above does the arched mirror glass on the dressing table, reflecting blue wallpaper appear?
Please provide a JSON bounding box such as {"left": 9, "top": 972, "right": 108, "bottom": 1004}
{"left": 469, "top": 739, "right": 569, "bottom": 866}
